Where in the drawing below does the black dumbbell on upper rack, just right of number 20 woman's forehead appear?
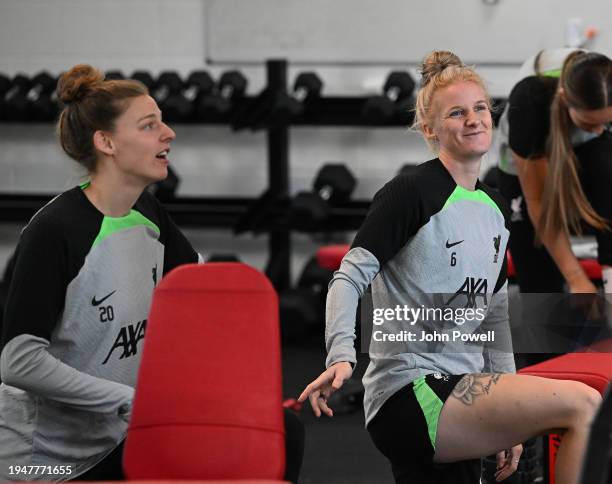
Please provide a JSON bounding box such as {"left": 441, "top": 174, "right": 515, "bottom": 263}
{"left": 163, "top": 71, "right": 215, "bottom": 122}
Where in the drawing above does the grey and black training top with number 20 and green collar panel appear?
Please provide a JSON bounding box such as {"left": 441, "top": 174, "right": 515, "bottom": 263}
{"left": 0, "top": 187, "right": 198, "bottom": 480}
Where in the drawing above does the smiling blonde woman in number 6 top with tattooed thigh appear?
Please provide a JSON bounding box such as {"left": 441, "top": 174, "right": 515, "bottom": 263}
{"left": 299, "top": 51, "right": 601, "bottom": 484}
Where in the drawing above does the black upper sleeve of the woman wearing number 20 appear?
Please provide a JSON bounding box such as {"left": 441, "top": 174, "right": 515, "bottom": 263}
{"left": 2, "top": 217, "right": 69, "bottom": 347}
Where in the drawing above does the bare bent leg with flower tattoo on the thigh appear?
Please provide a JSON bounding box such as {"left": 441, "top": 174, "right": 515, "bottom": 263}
{"left": 434, "top": 374, "right": 601, "bottom": 484}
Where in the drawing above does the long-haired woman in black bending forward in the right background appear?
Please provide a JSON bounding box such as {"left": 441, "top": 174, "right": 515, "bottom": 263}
{"left": 499, "top": 49, "right": 612, "bottom": 293}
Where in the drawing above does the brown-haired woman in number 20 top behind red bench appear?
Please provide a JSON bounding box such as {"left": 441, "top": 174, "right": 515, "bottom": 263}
{"left": 0, "top": 65, "right": 199, "bottom": 481}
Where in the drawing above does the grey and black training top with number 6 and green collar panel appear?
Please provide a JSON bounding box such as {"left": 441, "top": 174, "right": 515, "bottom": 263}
{"left": 326, "top": 159, "right": 515, "bottom": 424}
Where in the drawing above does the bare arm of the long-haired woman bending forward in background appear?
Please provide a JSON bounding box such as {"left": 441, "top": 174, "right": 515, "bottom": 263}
{"left": 512, "top": 151, "right": 597, "bottom": 293}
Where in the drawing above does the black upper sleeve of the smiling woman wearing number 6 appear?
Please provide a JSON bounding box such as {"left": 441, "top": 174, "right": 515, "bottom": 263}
{"left": 351, "top": 175, "right": 422, "bottom": 267}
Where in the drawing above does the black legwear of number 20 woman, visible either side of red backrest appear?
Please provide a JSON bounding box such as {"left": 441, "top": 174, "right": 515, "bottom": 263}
{"left": 76, "top": 408, "right": 304, "bottom": 483}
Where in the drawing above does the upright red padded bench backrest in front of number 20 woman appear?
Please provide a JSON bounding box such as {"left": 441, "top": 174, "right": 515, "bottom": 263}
{"left": 124, "top": 263, "right": 285, "bottom": 480}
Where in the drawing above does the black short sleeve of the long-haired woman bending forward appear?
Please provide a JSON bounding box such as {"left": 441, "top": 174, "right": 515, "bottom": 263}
{"left": 508, "top": 76, "right": 556, "bottom": 158}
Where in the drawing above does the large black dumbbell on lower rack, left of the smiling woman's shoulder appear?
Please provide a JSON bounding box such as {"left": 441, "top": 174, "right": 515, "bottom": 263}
{"left": 290, "top": 163, "right": 357, "bottom": 231}
